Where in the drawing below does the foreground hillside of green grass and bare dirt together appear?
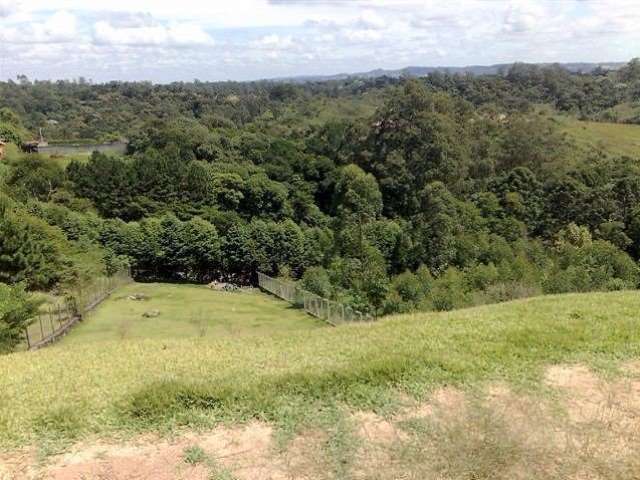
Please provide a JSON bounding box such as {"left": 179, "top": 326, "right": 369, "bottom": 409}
{"left": 0, "top": 292, "right": 640, "bottom": 479}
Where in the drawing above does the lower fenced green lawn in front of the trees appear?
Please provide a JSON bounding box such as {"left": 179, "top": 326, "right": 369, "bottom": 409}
{"left": 60, "top": 283, "right": 328, "bottom": 347}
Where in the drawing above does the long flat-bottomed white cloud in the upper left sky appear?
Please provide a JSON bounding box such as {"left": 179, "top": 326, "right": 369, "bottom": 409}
{"left": 93, "top": 21, "right": 214, "bottom": 47}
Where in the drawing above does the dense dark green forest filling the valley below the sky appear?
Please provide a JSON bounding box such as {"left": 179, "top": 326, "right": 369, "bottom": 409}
{"left": 0, "top": 60, "right": 640, "bottom": 348}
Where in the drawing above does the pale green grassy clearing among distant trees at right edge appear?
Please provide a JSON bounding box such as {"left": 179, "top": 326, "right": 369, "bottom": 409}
{"left": 557, "top": 117, "right": 640, "bottom": 158}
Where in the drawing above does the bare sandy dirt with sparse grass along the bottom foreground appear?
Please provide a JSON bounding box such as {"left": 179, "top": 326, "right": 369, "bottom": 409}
{"left": 0, "top": 363, "right": 640, "bottom": 480}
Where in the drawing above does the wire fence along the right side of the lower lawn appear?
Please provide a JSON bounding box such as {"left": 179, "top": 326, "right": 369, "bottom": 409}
{"left": 258, "top": 272, "right": 371, "bottom": 326}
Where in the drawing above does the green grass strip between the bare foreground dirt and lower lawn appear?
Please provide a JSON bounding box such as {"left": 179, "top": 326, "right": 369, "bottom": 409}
{"left": 0, "top": 286, "right": 640, "bottom": 445}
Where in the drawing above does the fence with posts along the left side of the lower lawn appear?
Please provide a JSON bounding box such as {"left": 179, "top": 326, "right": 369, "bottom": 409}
{"left": 25, "top": 271, "right": 131, "bottom": 350}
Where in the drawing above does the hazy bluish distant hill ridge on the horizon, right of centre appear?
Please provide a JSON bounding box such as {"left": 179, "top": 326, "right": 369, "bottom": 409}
{"left": 272, "top": 62, "right": 625, "bottom": 82}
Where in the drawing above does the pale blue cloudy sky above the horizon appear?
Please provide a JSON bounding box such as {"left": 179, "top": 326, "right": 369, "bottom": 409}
{"left": 0, "top": 0, "right": 640, "bottom": 83}
